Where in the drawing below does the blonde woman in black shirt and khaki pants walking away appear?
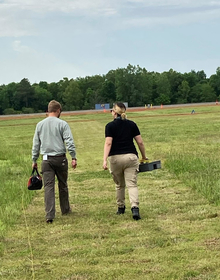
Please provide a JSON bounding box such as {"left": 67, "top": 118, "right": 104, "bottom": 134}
{"left": 103, "top": 103, "right": 148, "bottom": 220}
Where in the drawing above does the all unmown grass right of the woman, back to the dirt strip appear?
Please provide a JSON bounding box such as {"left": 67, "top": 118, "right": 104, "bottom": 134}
{"left": 131, "top": 107, "right": 220, "bottom": 205}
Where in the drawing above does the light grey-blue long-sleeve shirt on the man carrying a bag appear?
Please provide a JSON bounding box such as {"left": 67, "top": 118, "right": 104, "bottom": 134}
{"left": 32, "top": 117, "right": 76, "bottom": 162}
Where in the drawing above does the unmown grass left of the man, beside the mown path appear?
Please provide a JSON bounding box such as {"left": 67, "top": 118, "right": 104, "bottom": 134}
{"left": 0, "top": 120, "right": 38, "bottom": 237}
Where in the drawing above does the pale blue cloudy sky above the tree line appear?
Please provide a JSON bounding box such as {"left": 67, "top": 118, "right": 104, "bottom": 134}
{"left": 0, "top": 0, "right": 220, "bottom": 84}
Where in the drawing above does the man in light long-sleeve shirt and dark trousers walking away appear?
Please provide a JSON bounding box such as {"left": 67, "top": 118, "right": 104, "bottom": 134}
{"left": 32, "top": 100, "right": 77, "bottom": 223}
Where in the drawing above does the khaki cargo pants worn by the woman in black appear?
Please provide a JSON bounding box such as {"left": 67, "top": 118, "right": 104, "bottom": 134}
{"left": 109, "top": 154, "right": 139, "bottom": 207}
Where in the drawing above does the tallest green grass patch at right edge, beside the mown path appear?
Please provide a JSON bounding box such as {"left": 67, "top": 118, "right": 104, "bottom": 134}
{"left": 165, "top": 150, "right": 220, "bottom": 205}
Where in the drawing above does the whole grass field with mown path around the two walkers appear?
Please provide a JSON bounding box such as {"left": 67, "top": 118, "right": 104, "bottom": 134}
{"left": 0, "top": 106, "right": 220, "bottom": 280}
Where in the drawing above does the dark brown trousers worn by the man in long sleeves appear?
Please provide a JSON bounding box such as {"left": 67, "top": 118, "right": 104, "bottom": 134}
{"left": 42, "top": 157, "right": 70, "bottom": 220}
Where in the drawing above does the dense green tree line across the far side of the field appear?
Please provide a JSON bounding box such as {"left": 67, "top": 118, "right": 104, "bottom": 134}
{"left": 0, "top": 64, "right": 220, "bottom": 115}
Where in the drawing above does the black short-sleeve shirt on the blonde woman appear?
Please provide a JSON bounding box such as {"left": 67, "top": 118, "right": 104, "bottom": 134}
{"left": 105, "top": 118, "right": 140, "bottom": 156}
